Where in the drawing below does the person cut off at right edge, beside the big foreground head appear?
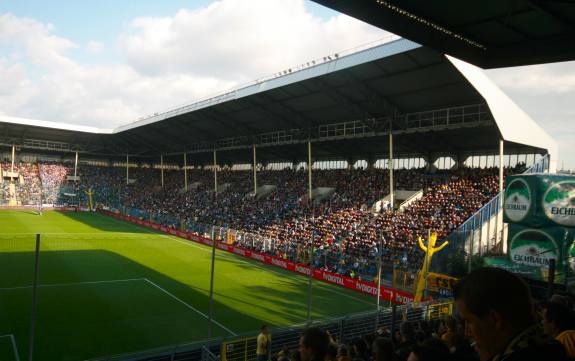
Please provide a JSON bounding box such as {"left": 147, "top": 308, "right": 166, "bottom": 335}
{"left": 542, "top": 302, "right": 575, "bottom": 359}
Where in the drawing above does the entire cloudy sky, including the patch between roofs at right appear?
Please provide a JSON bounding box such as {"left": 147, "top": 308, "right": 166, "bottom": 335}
{"left": 0, "top": 0, "right": 575, "bottom": 169}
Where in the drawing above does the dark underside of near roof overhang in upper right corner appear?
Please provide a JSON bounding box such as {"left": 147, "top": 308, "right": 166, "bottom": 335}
{"left": 313, "top": 0, "right": 575, "bottom": 68}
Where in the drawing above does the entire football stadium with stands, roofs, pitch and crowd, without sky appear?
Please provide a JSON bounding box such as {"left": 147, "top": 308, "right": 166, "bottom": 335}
{"left": 0, "top": 0, "right": 575, "bottom": 361}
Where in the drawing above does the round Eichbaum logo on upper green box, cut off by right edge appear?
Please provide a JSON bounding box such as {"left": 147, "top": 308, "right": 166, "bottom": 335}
{"left": 543, "top": 180, "right": 575, "bottom": 227}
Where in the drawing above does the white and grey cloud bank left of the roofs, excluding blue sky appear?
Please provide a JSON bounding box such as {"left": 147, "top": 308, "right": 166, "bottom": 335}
{"left": 0, "top": 0, "right": 386, "bottom": 127}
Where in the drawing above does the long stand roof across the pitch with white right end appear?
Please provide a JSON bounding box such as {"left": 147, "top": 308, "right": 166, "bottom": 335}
{"left": 0, "top": 39, "right": 557, "bottom": 164}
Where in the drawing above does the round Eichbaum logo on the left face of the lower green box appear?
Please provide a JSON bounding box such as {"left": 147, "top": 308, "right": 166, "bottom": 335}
{"left": 510, "top": 229, "right": 559, "bottom": 267}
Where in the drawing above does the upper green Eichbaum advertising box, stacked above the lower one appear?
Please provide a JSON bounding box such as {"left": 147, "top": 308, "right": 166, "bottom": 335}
{"left": 503, "top": 174, "right": 575, "bottom": 227}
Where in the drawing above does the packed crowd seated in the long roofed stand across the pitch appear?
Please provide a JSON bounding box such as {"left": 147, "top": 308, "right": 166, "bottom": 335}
{"left": 1, "top": 163, "right": 512, "bottom": 277}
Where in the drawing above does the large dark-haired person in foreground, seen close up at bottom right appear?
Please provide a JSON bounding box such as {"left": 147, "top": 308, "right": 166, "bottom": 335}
{"left": 454, "top": 268, "right": 567, "bottom": 361}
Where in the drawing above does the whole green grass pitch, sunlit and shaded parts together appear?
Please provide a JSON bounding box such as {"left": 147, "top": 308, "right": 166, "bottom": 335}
{"left": 0, "top": 211, "right": 375, "bottom": 361}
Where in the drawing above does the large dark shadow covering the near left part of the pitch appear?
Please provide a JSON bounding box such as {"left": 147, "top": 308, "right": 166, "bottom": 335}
{"left": 0, "top": 250, "right": 261, "bottom": 360}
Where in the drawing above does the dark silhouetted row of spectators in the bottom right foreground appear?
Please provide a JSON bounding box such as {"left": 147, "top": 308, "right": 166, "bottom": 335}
{"left": 271, "top": 268, "right": 575, "bottom": 361}
